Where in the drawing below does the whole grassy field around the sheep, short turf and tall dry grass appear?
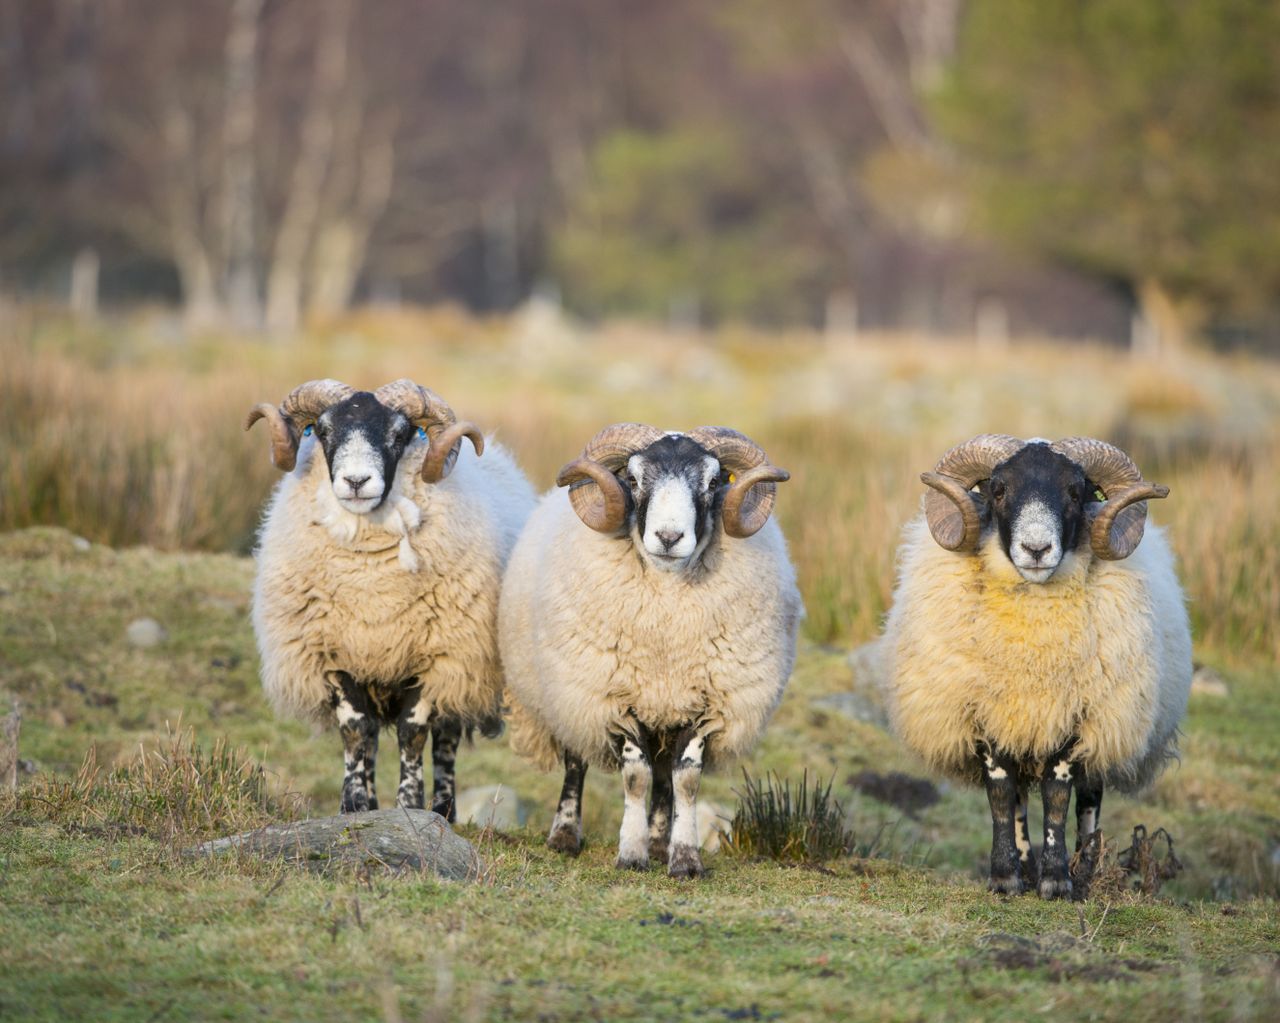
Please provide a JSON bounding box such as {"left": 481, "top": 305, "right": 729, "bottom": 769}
{"left": 0, "top": 312, "right": 1280, "bottom": 1020}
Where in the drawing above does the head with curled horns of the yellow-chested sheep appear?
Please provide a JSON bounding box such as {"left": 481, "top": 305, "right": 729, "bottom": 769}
{"left": 920, "top": 434, "right": 1169, "bottom": 583}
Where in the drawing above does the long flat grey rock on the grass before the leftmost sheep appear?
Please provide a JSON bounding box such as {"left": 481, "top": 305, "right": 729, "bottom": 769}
{"left": 189, "top": 807, "right": 484, "bottom": 881}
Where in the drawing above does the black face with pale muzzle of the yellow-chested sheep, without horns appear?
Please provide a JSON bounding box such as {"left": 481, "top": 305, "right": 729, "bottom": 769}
{"left": 980, "top": 442, "right": 1093, "bottom": 583}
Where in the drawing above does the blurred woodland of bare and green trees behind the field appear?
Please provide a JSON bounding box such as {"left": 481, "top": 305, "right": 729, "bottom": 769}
{"left": 0, "top": 0, "right": 1280, "bottom": 351}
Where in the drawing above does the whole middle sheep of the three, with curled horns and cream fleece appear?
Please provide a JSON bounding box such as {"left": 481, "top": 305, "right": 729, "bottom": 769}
{"left": 499, "top": 423, "right": 803, "bottom": 877}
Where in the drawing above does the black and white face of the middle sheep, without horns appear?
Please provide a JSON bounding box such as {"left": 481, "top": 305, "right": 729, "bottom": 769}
{"left": 626, "top": 434, "right": 722, "bottom": 571}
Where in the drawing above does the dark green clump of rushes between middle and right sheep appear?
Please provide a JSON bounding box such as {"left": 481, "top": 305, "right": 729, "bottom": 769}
{"left": 727, "top": 771, "right": 854, "bottom": 863}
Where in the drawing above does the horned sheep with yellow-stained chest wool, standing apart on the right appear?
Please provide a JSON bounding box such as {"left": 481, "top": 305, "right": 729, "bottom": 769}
{"left": 881, "top": 434, "right": 1192, "bottom": 898}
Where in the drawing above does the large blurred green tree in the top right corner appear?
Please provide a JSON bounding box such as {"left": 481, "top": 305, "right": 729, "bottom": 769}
{"left": 936, "top": 0, "right": 1280, "bottom": 346}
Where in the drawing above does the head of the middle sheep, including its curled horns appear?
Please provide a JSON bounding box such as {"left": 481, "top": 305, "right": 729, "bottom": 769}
{"left": 556, "top": 423, "right": 790, "bottom": 571}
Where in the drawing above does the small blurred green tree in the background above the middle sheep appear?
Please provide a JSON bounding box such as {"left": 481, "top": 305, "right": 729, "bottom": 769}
{"left": 554, "top": 125, "right": 822, "bottom": 323}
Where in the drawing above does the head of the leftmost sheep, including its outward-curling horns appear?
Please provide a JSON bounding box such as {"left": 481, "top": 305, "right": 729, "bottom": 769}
{"left": 244, "top": 380, "right": 484, "bottom": 515}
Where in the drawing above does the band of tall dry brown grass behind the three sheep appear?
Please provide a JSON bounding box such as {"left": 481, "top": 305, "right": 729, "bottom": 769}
{"left": 0, "top": 310, "right": 1280, "bottom": 659}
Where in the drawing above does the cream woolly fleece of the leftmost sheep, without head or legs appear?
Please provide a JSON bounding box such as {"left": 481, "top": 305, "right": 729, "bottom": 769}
{"left": 253, "top": 438, "right": 535, "bottom": 723}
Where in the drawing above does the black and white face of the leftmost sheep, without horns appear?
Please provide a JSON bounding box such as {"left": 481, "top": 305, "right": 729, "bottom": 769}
{"left": 307, "top": 391, "right": 417, "bottom": 515}
